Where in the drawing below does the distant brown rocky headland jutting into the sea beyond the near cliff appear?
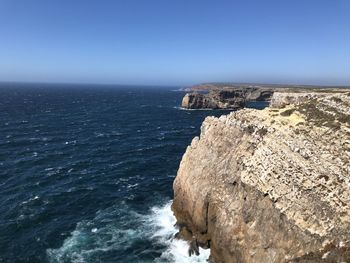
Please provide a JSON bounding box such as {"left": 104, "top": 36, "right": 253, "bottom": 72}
{"left": 181, "top": 87, "right": 273, "bottom": 109}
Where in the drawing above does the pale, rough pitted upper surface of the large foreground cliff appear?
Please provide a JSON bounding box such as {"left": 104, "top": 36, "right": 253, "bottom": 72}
{"left": 215, "top": 92, "right": 350, "bottom": 236}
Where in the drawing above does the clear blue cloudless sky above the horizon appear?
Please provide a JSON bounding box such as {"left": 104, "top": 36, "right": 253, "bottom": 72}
{"left": 0, "top": 0, "right": 350, "bottom": 85}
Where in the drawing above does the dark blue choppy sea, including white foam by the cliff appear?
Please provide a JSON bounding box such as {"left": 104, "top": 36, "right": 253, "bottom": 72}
{"left": 0, "top": 84, "right": 265, "bottom": 263}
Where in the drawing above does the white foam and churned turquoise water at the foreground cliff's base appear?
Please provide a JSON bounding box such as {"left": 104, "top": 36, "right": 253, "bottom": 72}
{"left": 47, "top": 202, "right": 210, "bottom": 263}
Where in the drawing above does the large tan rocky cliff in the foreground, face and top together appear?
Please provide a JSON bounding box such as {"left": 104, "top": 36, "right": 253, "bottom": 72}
{"left": 173, "top": 92, "right": 350, "bottom": 263}
